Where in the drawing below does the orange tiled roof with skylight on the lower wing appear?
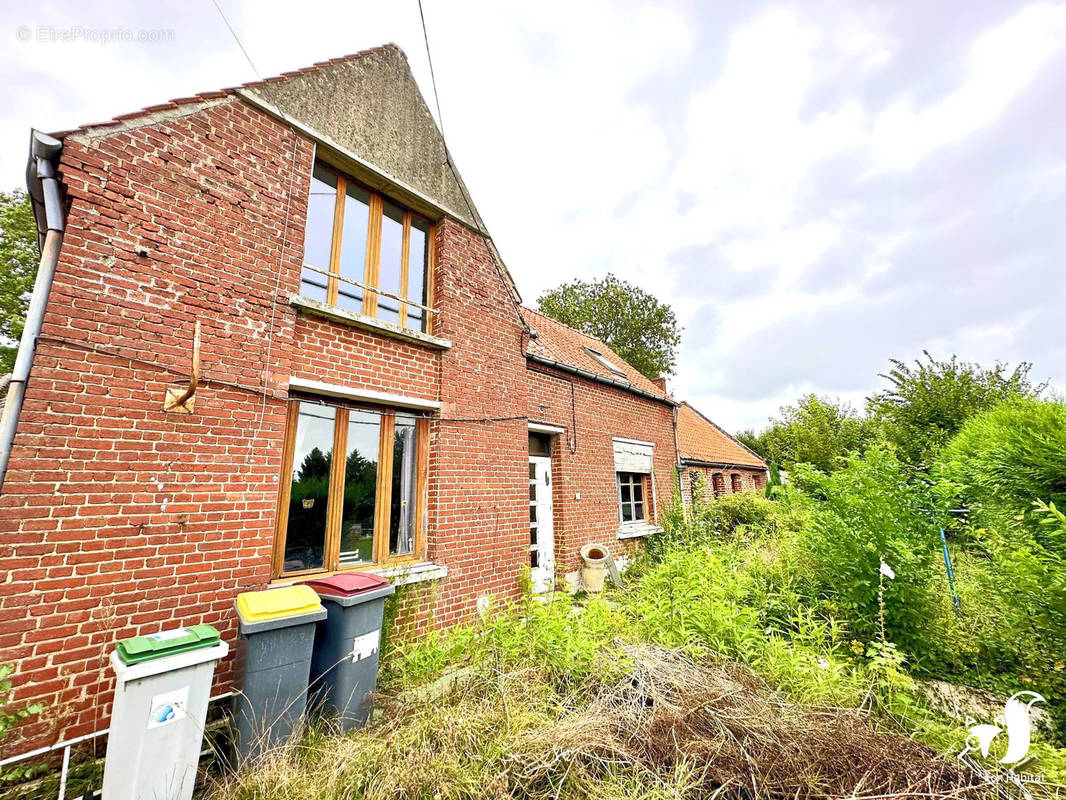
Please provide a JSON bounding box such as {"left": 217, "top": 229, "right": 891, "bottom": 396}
{"left": 521, "top": 306, "right": 676, "bottom": 405}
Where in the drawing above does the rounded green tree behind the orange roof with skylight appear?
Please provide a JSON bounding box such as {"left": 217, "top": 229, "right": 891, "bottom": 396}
{"left": 537, "top": 274, "right": 681, "bottom": 379}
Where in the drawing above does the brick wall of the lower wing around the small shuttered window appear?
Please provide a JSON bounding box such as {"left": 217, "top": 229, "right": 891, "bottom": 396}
{"left": 529, "top": 362, "right": 677, "bottom": 578}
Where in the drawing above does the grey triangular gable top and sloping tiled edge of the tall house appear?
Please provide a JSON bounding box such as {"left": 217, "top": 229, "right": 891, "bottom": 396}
{"left": 46, "top": 44, "right": 520, "bottom": 302}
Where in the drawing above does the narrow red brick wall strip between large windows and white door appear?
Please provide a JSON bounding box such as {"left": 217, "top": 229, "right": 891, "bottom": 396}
{"left": 429, "top": 221, "right": 529, "bottom": 625}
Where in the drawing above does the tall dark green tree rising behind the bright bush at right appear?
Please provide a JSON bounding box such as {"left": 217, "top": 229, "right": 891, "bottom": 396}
{"left": 867, "top": 351, "right": 1047, "bottom": 469}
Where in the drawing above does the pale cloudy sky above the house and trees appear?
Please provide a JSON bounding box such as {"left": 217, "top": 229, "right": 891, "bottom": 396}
{"left": 0, "top": 0, "right": 1066, "bottom": 430}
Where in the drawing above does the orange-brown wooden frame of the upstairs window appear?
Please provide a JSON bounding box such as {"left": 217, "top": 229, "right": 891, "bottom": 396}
{"left": 302, "top": 161, "right": 437, "bottom": 335}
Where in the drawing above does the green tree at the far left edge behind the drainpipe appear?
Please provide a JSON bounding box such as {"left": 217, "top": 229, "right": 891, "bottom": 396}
{"left": 0, "top": 190, "right": 39, "bottom": 372}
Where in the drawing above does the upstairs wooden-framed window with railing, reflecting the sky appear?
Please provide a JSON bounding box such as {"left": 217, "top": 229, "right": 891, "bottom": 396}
{"left": 300, "top": 162, "right": 433, "bottom": 333}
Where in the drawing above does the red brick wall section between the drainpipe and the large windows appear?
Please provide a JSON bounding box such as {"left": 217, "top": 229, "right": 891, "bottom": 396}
{"left": 0, "top": 101, "right": 312, "bottom": 750}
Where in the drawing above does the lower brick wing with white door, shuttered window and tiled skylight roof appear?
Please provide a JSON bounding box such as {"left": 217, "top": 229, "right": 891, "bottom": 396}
{"left": 522, "top": 308, "right": 677, "bottom": 593}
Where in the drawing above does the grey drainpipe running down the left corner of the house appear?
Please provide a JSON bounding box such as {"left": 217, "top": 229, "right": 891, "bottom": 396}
{"left": 0, "top": 130, "right": 65, "bottom": 492}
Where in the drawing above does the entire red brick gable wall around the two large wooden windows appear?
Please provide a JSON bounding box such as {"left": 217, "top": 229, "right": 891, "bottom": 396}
{"left": 0, "top": 100, "right": 528, "bottom": 754}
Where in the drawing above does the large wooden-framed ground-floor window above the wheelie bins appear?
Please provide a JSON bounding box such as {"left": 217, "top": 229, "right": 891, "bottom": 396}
{"left": 273, "top": 400, "right": 429, "bottom": 577}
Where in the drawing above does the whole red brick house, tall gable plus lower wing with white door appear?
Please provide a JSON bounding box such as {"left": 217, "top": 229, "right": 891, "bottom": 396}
{"left": 0, "top": 45, "right": 684, "bottom": 750}
